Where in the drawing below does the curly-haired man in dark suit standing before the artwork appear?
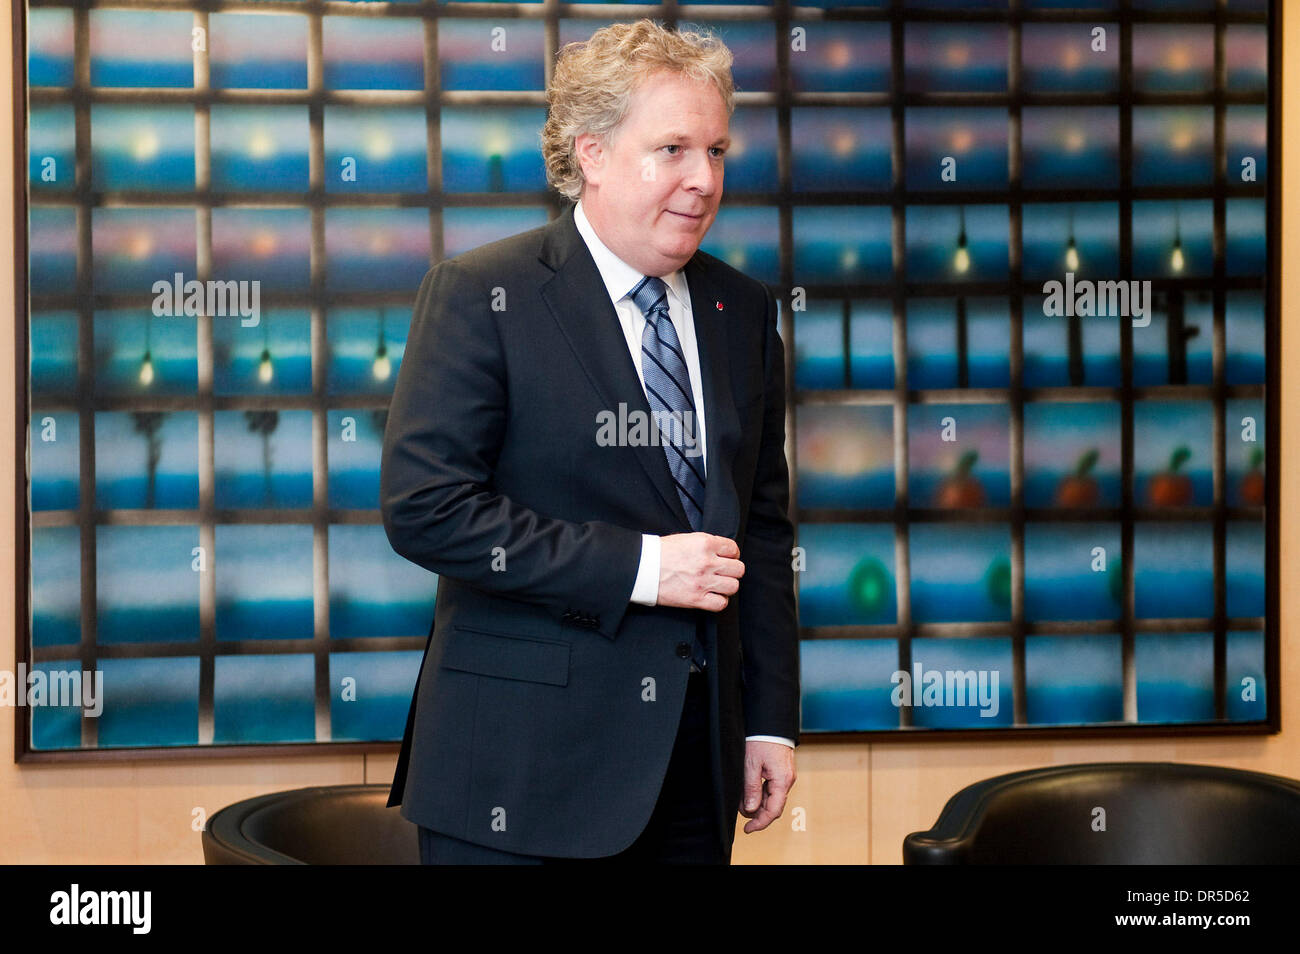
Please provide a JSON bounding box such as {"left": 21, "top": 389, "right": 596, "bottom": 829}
{"left": 381, "top": 21, "right": 800, "bottom": 863}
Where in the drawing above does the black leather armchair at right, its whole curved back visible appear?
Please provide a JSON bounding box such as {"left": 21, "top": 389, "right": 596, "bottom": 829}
{"left": 902, "top": 762, "right": 1300, "bottom": 864}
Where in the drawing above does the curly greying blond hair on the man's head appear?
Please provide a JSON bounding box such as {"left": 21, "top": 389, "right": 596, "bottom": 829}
{"left": 541, "top": 19, "right": 736, "bottom": 201}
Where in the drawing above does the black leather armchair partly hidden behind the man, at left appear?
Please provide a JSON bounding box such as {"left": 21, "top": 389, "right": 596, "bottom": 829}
{"left": 203, "top": 782, "right": 420, "bottom": 864}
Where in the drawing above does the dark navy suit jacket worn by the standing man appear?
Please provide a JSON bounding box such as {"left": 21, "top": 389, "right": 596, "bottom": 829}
{"left": 380, "top": 207, "right": 800, "bottom": 858}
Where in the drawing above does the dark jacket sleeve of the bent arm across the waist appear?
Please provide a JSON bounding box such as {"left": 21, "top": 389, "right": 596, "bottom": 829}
{"left": 380, "top": 259, "right": 641, "bottom": 639}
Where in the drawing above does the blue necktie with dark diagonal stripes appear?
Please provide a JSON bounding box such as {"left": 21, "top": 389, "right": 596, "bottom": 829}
{"left": 628, "top": 276, "right": 705, "bottom": 530}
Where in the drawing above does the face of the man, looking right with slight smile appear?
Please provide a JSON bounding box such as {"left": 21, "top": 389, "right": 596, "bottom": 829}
{"left": 576, "top": 71, "right": 731, "bottom": 276}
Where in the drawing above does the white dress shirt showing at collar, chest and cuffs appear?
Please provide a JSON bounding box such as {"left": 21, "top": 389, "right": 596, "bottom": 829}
{"left": 573, "top": 201, "right": 794, "bottom": 749}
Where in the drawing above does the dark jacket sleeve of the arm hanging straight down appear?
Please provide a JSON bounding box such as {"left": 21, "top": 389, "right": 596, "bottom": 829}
{"left": 738, "top": 286, "right": 800, "bottom": 743}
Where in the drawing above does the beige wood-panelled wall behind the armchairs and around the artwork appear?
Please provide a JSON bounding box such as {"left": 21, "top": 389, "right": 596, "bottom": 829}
{"left": 0, "top": 3, "right": 1300, "bottom": 864}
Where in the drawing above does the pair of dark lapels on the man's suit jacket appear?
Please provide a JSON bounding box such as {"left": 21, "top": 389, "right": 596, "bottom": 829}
{"left": 538, "top": 207, "right": 740, "bottom": 537}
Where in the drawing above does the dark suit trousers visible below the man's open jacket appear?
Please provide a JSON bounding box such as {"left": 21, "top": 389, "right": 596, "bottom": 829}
{"left": 420, "top": 672, "right": 731, "bottom": 864}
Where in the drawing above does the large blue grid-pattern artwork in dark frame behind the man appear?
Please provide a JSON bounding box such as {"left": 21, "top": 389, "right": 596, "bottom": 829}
{"left": 17, "top": 0, "right": 1278, "bottom": 758}
